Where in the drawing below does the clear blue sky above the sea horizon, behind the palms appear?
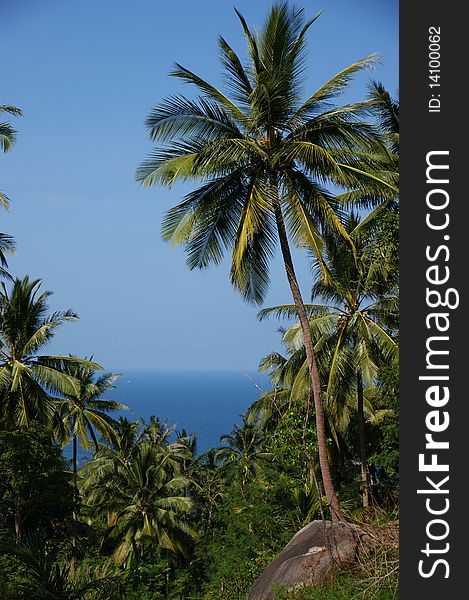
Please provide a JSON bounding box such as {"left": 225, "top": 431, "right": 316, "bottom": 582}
{"left": 0, "top": 0, "right": 398, "bottom": 370}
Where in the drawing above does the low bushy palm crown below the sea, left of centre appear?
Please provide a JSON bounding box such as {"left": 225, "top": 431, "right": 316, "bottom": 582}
{"left": 81, "top": 440, "right": 195, "bottom": 565}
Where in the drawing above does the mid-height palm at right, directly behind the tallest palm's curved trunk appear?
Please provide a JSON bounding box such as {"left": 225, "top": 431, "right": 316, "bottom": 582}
{"left": 260, "top": 215, "right": 398, "bottom": 506}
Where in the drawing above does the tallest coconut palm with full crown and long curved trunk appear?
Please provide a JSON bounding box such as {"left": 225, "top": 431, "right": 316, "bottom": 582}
{"left": 137, "top": 2, "right": 395, "bottom": 518}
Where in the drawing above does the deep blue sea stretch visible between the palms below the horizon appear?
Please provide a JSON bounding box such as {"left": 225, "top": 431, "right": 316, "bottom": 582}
{"left": 103, "top": 371, "right": 270, "bottom": 454}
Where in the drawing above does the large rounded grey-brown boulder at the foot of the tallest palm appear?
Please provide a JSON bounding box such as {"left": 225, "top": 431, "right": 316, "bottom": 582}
{"left": 248, "top": 521, "right": 375, "bottom": 600}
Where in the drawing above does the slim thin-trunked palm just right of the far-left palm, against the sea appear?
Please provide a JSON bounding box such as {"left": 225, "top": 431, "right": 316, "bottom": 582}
{"left": 57, "top": 358, "right": 128, "bottom": 573}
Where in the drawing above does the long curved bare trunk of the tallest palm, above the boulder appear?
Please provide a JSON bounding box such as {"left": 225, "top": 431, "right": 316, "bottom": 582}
{"left": 272, "top": 197, "right": 345, "bottom": 521}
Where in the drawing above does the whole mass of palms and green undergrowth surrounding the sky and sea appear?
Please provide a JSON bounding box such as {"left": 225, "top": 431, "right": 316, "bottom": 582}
{"left": 0, "top": 3, "right": 399, "bottom": 600}
